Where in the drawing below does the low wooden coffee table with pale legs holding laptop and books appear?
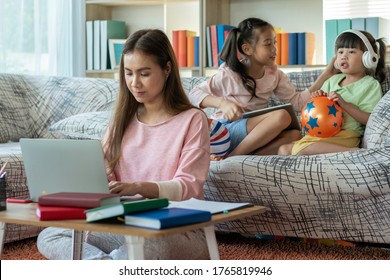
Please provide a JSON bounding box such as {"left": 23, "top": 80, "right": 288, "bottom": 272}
{"left": 0, "top": 203, "right": 266, "bottom": 260}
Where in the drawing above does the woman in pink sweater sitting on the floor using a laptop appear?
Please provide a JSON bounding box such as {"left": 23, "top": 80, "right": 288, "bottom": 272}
{"left": 38, "top": 29, "right": 210, "bottom": 259}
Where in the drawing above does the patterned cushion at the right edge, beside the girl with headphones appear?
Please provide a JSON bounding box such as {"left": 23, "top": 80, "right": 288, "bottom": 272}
{"left": 363, "top": 91, "right": 390, "bottom": 149}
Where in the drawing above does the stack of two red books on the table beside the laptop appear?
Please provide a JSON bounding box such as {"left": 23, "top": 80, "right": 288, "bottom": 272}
{"left": 36, "top": 192, "right": 120, "bottom": 221}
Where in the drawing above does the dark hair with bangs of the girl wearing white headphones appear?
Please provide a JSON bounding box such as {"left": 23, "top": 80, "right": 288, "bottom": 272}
{"left": 335, "top": 30, "right": 386, "bottom": 83}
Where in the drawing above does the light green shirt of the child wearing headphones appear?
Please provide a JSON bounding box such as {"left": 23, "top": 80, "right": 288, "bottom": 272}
{"left": 321, "top": 74, "right": 382, "bottom": 134}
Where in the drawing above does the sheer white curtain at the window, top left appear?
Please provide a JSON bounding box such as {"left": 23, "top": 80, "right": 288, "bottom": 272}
{"left": 0, "top": 0, "right": 85, "bottom": 76}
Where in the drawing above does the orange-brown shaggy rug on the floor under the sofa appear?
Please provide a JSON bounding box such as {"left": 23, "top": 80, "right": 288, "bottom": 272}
{"left": 1, "top": 233, "right": 390, "bottom": 260}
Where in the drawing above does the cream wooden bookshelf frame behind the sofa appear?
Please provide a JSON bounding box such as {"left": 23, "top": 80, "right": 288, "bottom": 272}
{"left": 86, "top": 0, "right": 323, "bottom": 78}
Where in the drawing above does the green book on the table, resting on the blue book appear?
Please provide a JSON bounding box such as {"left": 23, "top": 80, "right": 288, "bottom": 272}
{"left": 85, "top": 198, "right": 169, "bottom": 222}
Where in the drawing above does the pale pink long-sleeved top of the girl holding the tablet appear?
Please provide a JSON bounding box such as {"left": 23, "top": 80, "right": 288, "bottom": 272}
{"left": 189, "top": 63, "right": 310, "bottom": 116}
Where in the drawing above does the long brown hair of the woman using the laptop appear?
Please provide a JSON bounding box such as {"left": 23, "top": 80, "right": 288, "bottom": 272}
{"left": 103, "top": 29, "right": 195, "bottom": 172}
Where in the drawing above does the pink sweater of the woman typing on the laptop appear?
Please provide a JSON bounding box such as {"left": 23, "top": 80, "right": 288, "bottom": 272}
{"left": 111, "top": 109, "right": 210, "bottom": 200}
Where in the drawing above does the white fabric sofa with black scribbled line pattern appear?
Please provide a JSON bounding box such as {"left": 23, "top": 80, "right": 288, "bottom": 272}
{"left": 0, "top": 66, "right": 390, "bottom": 244}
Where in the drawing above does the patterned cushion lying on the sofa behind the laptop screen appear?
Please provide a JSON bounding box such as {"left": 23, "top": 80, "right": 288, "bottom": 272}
{"left": 49, "top": 111, "right": 111, "bottom": 140}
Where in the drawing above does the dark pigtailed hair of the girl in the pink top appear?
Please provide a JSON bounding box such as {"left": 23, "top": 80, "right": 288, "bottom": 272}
{"left": 219, "top": 18, "right": 273, "bottom": 97}
